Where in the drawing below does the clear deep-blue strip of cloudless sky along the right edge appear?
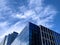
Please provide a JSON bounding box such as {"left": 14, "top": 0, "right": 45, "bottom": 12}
{"left": 44, "top": 0, "right": 60, "bottom": 33}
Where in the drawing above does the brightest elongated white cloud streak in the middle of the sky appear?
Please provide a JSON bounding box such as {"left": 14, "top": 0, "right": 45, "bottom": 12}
{"left": 12, "top": 10, "right": 34, "bottom": 19}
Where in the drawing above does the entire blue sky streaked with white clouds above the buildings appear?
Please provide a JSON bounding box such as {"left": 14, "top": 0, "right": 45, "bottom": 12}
{"left": 0, "top": 0, "right": 60, "bottom": 41}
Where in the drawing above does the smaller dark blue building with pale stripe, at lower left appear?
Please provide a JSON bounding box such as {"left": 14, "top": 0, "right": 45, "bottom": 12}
{"left": 0, "top": 32, "right": 18, "bottom": 45}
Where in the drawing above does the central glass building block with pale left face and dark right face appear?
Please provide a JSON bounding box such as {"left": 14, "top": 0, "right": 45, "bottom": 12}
{"left": 11, "top": 23, "right": 42, "bottom": 45}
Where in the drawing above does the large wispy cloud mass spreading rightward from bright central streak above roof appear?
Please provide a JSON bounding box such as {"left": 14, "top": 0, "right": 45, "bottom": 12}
{"left": 11, "top": 6, "right": 56, "bottom": 28}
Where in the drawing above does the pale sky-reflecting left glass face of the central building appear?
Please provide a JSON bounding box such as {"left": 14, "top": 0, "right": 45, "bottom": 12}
{"left": 11, "top": 25, "right": 29, "bottom": 45}
